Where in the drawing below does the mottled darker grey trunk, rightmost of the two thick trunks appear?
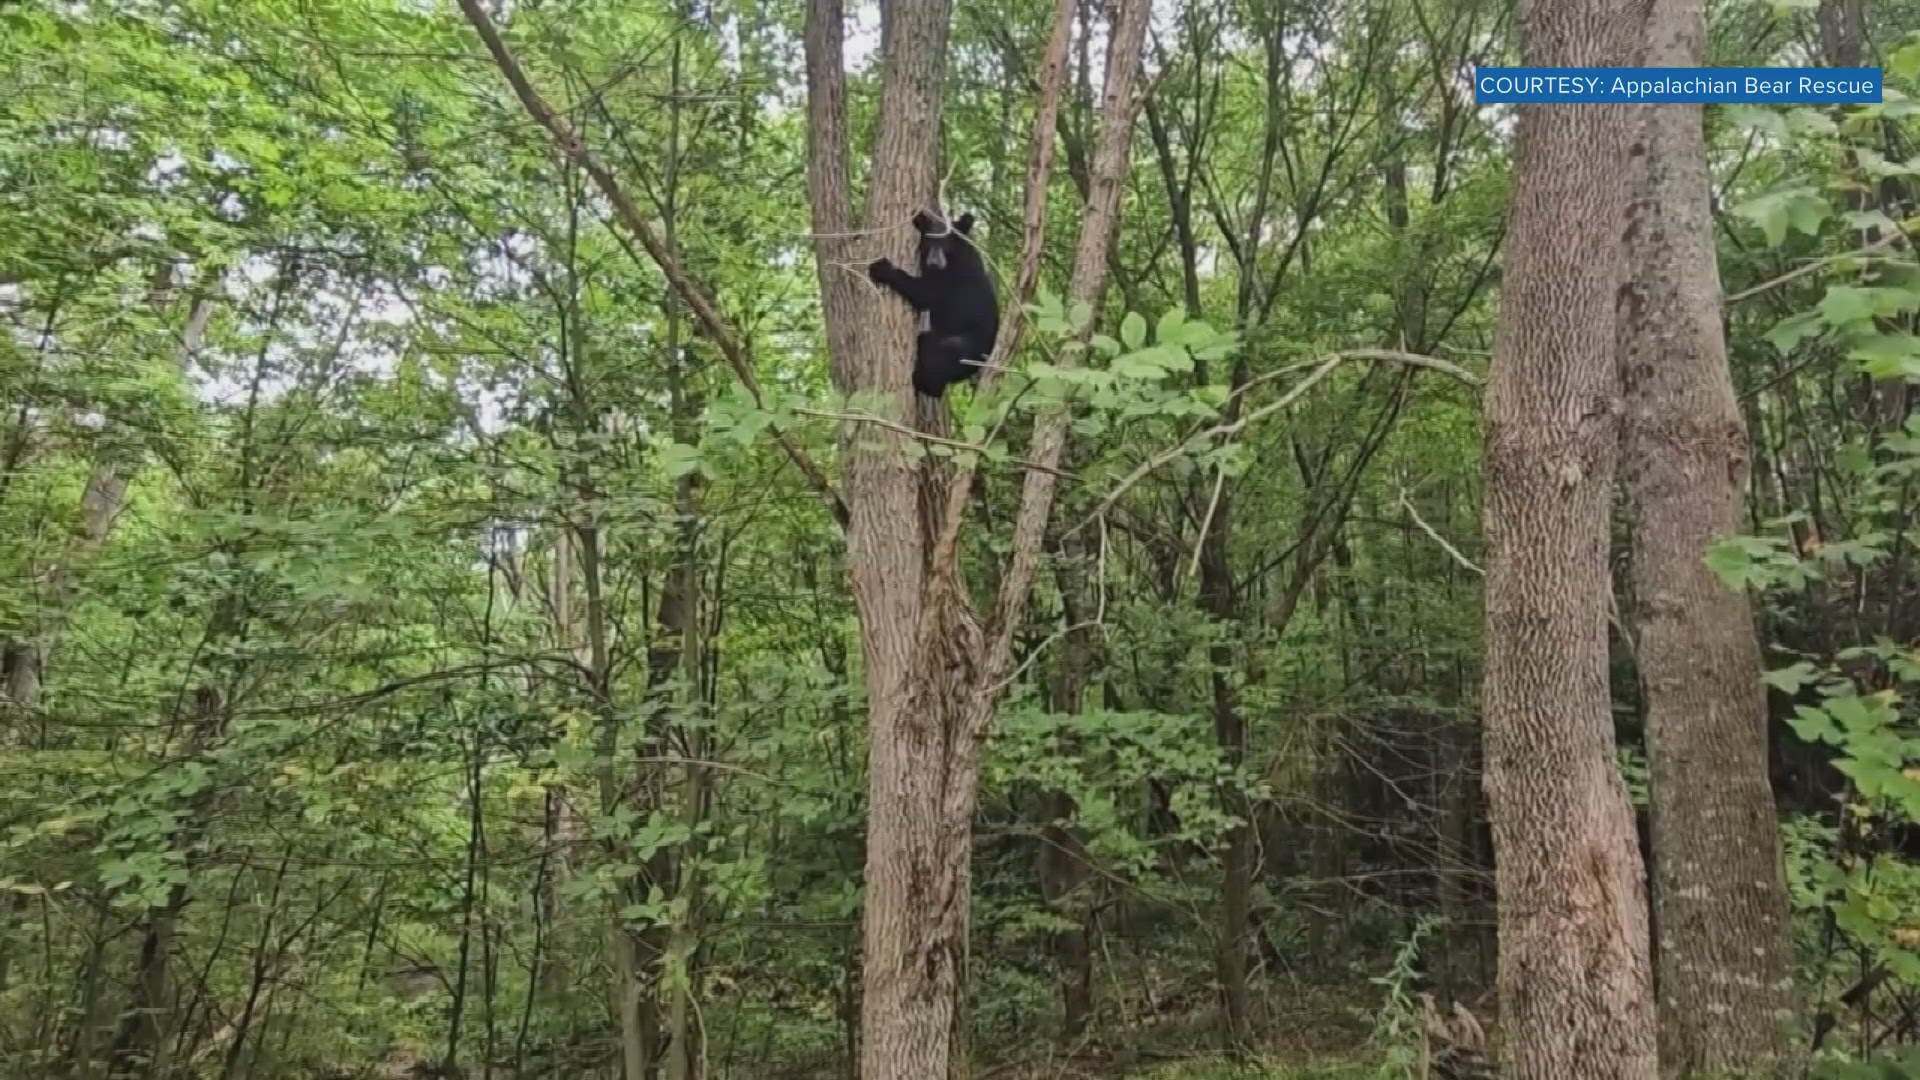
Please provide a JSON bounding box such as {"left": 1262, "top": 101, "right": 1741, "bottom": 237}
{"left": 1619, "top": 0, "right": 1793, "bottom": 1076}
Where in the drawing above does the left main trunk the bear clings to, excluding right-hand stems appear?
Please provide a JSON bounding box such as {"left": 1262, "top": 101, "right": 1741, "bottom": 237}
{"left": 804, "top": 0, "right": 962, "bottom": 1080}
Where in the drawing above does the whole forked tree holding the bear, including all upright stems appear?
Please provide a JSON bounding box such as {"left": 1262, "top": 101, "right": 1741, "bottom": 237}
{"left": 806, "top": 0, "right": 1148, "bottom": 1060}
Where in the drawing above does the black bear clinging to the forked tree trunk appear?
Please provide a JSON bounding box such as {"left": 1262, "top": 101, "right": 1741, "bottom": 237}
{"left": 866, "top": 209, "right": 1000, "bottom": 398}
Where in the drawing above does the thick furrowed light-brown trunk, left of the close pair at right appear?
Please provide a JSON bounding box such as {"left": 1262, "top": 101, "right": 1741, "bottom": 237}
{"left": 1482, "top": 0, "right": 1657, "bottom": 1080}
